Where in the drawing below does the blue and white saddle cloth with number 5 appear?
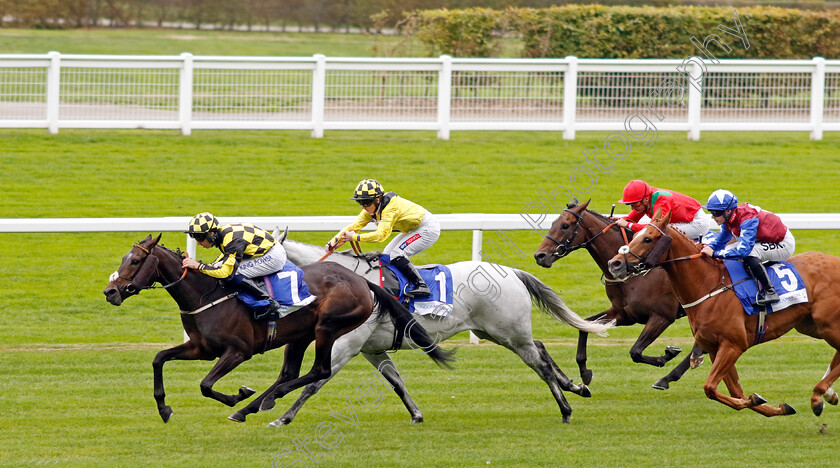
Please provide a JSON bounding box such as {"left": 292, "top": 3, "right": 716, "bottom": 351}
{"left": 724, "top": 260, "right": 808, "bottom": 315}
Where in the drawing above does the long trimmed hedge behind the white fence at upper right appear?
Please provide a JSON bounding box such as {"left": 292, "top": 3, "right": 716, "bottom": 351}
{"left": 409, "top": 5, "right": 840, "bottom": 58}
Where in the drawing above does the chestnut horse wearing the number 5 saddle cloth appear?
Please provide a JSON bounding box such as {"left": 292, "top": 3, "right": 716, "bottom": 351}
{"left": 609, "top": 210, "right": 840, "bottom": 416}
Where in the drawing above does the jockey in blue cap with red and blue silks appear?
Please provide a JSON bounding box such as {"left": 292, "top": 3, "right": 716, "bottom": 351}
{"left": 702, "top": 189, "right": 796, "bottom": 306}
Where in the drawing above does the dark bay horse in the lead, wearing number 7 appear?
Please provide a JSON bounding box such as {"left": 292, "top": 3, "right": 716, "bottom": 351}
{"left": 104, "top": 235, "right": 452, "bottom": 422}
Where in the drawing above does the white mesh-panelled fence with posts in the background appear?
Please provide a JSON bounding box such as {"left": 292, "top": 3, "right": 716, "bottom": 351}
{"left": 0, "top": 52, "right": 840, "bottom": 140}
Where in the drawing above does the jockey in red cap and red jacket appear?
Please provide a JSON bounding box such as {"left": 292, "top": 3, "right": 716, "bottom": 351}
{"left": 617, "top": 180, "right": 709, "bottom": 241}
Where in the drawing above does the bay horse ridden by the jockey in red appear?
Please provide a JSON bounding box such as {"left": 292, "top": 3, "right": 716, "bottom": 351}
{"left": 534, "top": 200, "right": 702, "bottom": 390}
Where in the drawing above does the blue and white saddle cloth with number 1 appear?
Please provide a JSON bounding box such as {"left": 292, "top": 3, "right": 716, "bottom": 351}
{"left": 379, "top": 254, "right": 452, "bottom": 317}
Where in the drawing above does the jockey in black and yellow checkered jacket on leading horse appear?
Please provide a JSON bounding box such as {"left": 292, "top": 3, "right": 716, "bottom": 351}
{"left": 183, "top": 212, "right": 286, "bottom": 318}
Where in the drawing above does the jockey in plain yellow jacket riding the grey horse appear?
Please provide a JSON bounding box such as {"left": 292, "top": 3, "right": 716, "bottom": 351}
{"left": 326, "top": 179, "right": 440, "bottom": 297}
